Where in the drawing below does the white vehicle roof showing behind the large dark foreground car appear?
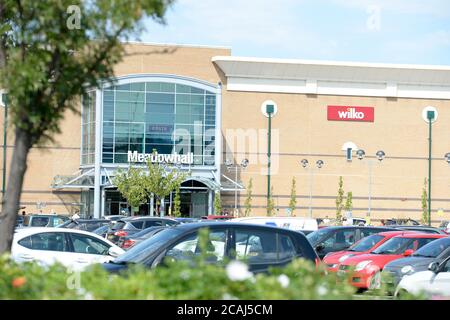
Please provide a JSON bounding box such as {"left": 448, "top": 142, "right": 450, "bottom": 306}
{"left": 230, "top": 217, "right": 319, "bottom": 232}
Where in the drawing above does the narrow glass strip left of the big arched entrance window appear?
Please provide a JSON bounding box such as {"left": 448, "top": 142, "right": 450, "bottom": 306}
{"left": 81, "top": 91, "right": 95, "bottom": 165}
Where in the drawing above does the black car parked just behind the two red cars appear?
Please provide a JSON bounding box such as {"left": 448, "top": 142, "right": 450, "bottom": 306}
{"left": 306, "top": 226, "right": 396, "bottom": 259}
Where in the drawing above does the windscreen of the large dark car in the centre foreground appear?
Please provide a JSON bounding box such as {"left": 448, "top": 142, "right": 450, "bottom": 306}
{"left": 113, "top": 228, "right": 183, "bottom": 264}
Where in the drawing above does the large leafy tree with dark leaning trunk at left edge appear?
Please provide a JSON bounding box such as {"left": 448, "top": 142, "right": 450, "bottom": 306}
{"left": 0, "top": 0, "right": 173, "bottom": 254}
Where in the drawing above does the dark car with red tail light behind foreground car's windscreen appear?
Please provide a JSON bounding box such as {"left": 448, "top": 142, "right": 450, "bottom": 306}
{"left": 107, "top": 217, "right": 181, "bottom": 243}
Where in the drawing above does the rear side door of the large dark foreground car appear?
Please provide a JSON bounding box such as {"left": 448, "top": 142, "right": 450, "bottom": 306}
{"left": 232, "top": 228, "right": 298, "bottom": 273}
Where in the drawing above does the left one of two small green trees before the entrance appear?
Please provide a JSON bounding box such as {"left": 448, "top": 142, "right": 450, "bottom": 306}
{"left": 112, "top": 167, "right": 148, "bottom": 214}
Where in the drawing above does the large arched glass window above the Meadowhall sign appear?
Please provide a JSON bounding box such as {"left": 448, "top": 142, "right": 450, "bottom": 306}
{"left": 101, "top": 82, "right": 216, "bottom": 165}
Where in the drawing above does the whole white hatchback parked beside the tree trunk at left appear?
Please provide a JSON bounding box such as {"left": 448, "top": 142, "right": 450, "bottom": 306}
{"left": 11, "top": 227, "right": 125, "bottom": 270}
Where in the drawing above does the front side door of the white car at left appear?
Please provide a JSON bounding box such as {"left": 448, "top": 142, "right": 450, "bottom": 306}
{"left": 68, "top": 232, "right": 112, "bottom": 269}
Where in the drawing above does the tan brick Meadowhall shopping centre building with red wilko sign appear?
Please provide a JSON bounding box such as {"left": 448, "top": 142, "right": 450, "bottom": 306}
{"left": 1, "top": 43, "right": 450, "bottom": 222}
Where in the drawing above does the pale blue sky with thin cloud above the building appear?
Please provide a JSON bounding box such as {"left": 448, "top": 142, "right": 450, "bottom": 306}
{"left": 139, "top": 0, "right": 450, "bottom": 65}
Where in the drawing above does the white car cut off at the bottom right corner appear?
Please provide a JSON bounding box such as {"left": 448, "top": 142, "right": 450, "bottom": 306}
{"left": 395, "top": 257, "right": 450, "bottom": 297}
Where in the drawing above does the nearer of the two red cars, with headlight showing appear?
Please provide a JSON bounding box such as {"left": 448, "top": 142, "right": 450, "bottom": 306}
{"left": 338, "top": 233, "right": 446, "bottom": 289}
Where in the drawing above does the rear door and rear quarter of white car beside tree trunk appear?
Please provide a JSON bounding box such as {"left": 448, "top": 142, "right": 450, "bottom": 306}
{"left": 13, "top": 232, "right": 70, "bottom": 266}
